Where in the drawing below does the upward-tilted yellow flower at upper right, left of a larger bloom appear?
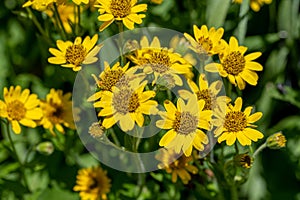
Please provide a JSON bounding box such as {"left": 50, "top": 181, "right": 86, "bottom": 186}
{"left": 184, "top": 25, "right": 225, "bottom": 57}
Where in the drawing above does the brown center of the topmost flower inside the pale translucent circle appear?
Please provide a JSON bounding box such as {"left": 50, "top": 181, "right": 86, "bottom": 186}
{"left": 148, "top": 50, "right": 171, "bottom": 74}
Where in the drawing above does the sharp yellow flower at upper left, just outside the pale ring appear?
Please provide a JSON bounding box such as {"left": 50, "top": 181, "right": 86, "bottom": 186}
{"left": 48, "top": 34, "right": 102, "bottom": 71}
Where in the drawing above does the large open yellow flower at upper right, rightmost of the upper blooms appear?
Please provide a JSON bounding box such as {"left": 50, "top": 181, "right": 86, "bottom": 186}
{"left": 205, "top": 37, "right": 263, "bottom": 90}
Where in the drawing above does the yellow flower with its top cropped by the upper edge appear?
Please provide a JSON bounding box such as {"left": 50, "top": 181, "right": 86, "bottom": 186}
{"left": 95, "top": 0, "right": 147, "bottom": 31}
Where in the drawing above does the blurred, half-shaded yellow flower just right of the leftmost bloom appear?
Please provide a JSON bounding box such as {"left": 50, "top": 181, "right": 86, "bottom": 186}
{"left": 40, "top": 89, "right": 75, "bottom": 135}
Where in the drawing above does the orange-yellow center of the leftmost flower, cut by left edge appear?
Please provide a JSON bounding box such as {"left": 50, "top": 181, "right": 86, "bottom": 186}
{"left": 7, "top": 100, "right": 26, "bottom": 121}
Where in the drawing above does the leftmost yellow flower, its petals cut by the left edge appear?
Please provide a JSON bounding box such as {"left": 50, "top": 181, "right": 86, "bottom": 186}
{"left": 0, "top": 86, "right": 43, "bottom": 134}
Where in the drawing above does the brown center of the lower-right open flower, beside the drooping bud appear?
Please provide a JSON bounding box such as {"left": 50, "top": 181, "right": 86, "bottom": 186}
{"left": 224, "top": 111, "right": 247, "bottom": 132}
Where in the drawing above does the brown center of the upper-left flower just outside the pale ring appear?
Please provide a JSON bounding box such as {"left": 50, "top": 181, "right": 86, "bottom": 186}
{"left": 65, "top": 44, "right": 86, "bottom": 66}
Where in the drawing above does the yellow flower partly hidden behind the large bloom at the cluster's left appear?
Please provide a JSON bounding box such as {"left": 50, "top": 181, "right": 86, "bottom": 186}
{"left": 88, "top": 61, "right": 139, "bottom": 101}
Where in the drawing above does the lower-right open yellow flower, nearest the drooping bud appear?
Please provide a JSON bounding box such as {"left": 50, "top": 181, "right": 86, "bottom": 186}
{"left": 212, "top": 97, "right": 264, "bottom": 146}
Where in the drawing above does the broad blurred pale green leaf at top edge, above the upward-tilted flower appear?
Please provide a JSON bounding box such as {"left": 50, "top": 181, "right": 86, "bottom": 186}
{"left": 206, "top": 0, "right": 231, "bottom": 27}
